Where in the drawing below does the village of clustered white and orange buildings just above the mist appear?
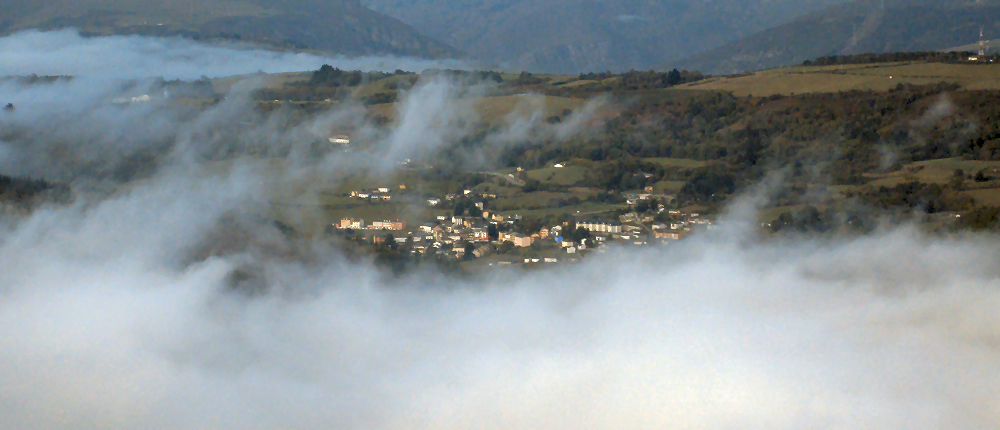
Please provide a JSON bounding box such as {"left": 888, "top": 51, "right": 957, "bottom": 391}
{"left": 330, "top": 185, "right": 715, "bottom": 266}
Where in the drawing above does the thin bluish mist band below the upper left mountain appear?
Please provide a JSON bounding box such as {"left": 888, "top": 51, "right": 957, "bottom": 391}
{"left": 0, "top": 30, "right": 464, "bottom": 79}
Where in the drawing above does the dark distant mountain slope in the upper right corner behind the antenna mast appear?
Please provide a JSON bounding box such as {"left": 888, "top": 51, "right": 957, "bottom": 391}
{"left": 680, "top": 0, "right": 1000, "bottom": 74}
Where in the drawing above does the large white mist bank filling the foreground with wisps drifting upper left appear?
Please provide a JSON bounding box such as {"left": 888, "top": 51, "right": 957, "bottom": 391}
{"left": 0, "top": 31, "right": 1000, "bottom": 430}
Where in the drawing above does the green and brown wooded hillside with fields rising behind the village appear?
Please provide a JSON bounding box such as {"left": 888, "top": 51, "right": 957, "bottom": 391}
{"left": 197, "top": 61, "right": 1000, "bottom": 234}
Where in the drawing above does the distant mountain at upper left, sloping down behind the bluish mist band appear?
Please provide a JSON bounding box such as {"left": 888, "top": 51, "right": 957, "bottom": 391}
{"left": 0, "top": 0, "right": 463, "bottom": 58}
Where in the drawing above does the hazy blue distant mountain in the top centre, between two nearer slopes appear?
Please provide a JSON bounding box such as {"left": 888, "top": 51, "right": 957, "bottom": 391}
{"left": 362, "top": 0, "right": 847, "bottom": 73}
